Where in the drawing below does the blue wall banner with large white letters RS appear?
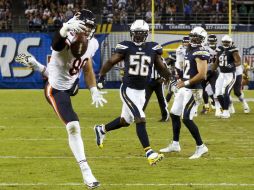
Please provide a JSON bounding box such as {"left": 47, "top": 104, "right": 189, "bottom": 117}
{"left": 0, "top": 33, "right": 105, "bottom": 89}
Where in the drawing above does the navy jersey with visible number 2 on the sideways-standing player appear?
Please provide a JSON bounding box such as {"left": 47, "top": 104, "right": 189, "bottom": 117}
{"left": 183, "top": 46, "right": 210, "bottom": 89}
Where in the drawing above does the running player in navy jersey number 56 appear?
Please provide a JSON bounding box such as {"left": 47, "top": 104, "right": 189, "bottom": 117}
{"left": 94, "top": 20, "right": 170, "bottom": 165}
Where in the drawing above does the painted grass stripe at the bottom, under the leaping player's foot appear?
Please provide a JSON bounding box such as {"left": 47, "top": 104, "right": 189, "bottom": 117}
{"left": 0, "top": 183, "right": 254, "bottom": 187}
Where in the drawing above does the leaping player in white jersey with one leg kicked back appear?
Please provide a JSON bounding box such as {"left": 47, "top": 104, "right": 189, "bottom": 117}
{"left": 16, "top": 9, "right": 106, "bottom": 188}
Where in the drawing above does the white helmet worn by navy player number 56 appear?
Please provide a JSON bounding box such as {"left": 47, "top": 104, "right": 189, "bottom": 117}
{"left": 130, "top": 20, "right": 149, "bottom": 46}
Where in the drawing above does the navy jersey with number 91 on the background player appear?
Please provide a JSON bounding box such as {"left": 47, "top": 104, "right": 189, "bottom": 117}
{"left": 216, "top": 46, "right": 239, "bottom": 73}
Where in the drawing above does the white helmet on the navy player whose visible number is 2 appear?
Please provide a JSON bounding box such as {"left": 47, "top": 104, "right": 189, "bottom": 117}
{"left": 189, "top": 26, "right": 207, "bottom": 47}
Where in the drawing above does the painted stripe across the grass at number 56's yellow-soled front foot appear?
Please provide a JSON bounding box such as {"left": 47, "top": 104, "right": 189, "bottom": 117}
{"left": 0, "top": 155, "right": 254, "bottom": 160}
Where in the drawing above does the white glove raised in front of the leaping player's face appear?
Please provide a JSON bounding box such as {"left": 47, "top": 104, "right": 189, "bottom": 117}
{"left": 60, "top": 13, "right": 86, "bottom": 38}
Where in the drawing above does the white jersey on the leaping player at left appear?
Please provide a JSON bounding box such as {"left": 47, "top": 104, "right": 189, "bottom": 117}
{"left": 47, "top": 33, "right": 99, "bottom": 90}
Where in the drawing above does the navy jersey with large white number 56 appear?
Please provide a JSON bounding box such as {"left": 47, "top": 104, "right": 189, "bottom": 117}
{"left": 115, "top": 41, "right": 162, "bottom": 90}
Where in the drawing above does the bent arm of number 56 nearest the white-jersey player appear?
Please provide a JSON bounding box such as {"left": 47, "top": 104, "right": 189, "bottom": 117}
{"left": 97, "top": 53, "right": 124, "bottom": 89}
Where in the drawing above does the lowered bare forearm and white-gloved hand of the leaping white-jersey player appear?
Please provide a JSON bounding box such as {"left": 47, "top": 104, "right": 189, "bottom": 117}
{"left": 83, "top": 59, "right": 107, "bottom": 108}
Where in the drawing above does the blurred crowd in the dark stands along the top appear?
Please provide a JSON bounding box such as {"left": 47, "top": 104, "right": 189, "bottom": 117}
{"left": 0, "top": 0, "right": 254, "bottom": 31}
